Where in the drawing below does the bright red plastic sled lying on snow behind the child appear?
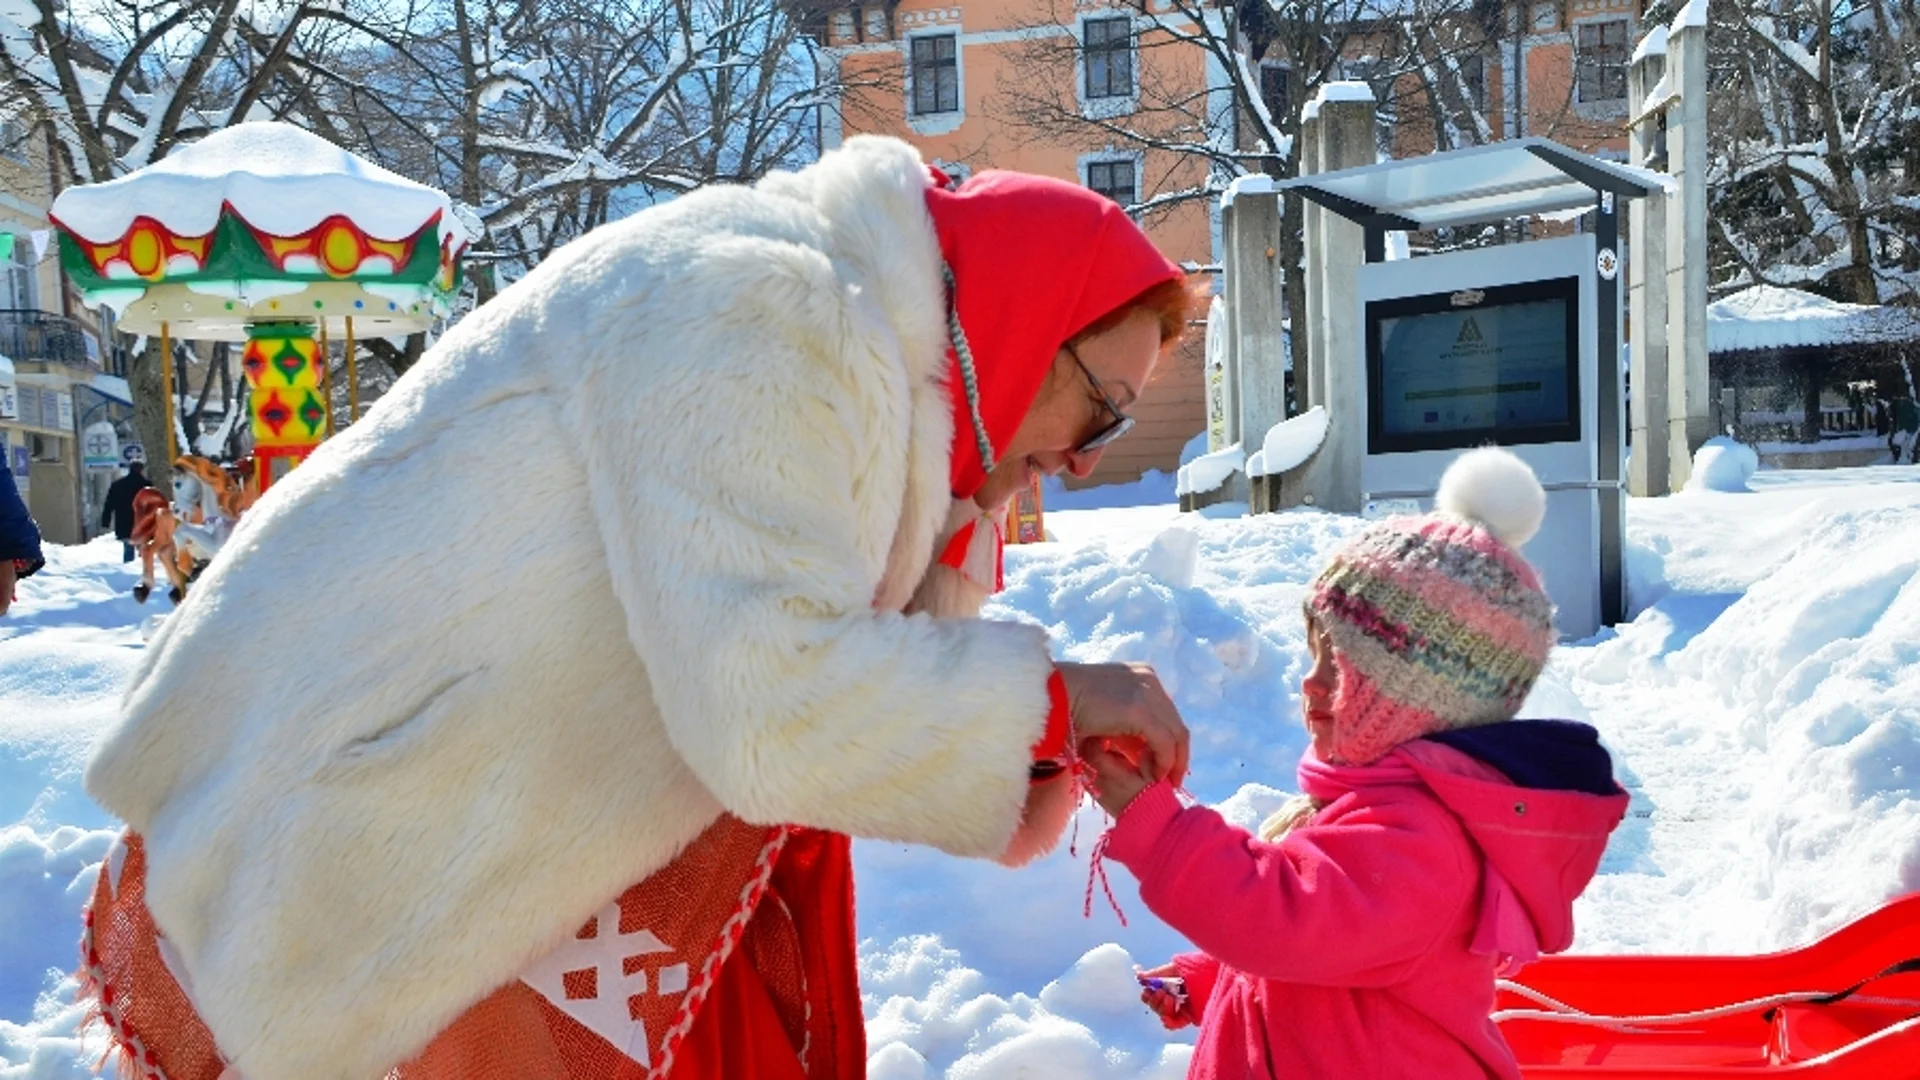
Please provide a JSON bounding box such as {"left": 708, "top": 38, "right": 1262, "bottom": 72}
{"left": 1494, "top": 894, "right": 1920, "bottom": 1080}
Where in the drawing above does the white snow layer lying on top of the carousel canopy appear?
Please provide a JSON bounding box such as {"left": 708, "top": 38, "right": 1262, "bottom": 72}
{"left": 52, "top": 121, "right": 467, "bottom": 246}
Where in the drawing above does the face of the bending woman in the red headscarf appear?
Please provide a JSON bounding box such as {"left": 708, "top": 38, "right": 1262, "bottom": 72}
{"left": 973, "top": 307, "right": 1160, "bottom": 509}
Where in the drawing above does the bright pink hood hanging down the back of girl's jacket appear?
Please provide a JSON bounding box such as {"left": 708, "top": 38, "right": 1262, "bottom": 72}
{"left": 1402, "top": 724, "right": 1626, "bottom": 953}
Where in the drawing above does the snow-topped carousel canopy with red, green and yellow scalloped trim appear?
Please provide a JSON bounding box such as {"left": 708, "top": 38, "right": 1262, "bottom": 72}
{"left": 52, "top": 121, "right": 468, "bottom": 340}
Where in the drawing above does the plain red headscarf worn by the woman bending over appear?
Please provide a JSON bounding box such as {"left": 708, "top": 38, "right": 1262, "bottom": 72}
{"left": 927, "top": 169, "right": 1183, "bottom": 498}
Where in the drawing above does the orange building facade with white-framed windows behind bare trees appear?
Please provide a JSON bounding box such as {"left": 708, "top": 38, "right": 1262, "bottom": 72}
{"left": 803, "top": 0, "right": 1644, "bottom": 482}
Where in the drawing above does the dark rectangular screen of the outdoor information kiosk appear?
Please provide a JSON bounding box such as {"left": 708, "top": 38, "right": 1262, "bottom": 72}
{"left": 1367, "top": 277, "right": 1580, "bottom": 454}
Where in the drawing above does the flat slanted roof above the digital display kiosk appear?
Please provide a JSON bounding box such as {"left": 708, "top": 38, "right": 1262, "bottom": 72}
{"left": 1275, "top": 136, "right": 1672, "bottom": 229}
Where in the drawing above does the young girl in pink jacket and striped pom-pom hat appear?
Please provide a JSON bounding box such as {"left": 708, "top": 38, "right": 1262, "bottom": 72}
{"left": 1089, "top": 448, "right": 1626, "bottom": 1080}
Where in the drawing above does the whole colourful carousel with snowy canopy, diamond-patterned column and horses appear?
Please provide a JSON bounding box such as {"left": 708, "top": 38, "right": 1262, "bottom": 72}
{"left": 52, "top": 121, "right": 468, "bottom": 601}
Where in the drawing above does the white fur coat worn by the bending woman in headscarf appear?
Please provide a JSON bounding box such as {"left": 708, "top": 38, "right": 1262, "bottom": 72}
{"left": 86, "top": 138, "right": 1050, "bottom": 1080}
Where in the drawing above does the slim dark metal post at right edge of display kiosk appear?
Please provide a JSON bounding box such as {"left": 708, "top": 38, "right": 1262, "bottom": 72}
{"left": 1594, "top": 192, "right": 1626, "bottom": 626}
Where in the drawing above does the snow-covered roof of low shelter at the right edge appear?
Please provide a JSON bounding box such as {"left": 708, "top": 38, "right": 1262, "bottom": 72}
{"left": 1707, "top": 284, "right": 1920, "bottom": 354}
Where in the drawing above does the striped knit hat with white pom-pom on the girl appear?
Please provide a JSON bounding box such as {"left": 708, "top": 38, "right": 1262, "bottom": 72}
{"left": 1306, "top": 446, "right": 1555, "bottom": 765}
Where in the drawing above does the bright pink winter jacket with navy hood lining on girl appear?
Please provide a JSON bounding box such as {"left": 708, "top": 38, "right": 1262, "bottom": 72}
{"left": 1106, "top": 721, "right": 1626, "bottom": 1080}
